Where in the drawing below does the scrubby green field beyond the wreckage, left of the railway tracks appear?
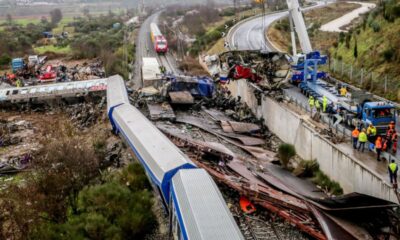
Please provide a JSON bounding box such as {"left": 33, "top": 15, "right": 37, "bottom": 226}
{"left": 0, "top": 9, "right": 135, "bottom": 79}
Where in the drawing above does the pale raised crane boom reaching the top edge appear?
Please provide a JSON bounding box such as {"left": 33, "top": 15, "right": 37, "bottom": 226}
{"left": 286, "top": 0, "right": 313, "bottom": 54}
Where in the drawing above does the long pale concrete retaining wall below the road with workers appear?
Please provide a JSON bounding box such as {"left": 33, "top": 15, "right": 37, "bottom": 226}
{"left": 228, "top": 80, "right": 398, "bottom": 203}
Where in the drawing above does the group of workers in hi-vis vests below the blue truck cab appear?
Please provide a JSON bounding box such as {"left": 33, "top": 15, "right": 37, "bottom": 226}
{"left": 352, "top": 121, "right": 399, "bottom": 188}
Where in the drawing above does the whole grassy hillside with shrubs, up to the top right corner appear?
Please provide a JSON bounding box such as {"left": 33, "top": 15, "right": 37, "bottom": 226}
{"left": 330, "top": 1, "right": 400, "bottom": 101}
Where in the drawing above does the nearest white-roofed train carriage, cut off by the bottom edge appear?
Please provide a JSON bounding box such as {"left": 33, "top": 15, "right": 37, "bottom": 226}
{"left": 171, "top": 169, "right": 244, "bottom": 240}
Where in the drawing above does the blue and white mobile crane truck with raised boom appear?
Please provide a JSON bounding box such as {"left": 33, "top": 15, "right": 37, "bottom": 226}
{"left": 286, "top": 0, "right": 396, "bottom": 134}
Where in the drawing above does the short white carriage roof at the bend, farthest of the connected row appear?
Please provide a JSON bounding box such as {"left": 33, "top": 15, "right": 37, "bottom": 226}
{"left": 107, "top": 75, "right": 129, "bottom": 112}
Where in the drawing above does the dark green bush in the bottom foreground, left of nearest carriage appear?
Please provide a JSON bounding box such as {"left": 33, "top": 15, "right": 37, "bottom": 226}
{"left": 33, "top": 163, "right": 157, "bottom": 239}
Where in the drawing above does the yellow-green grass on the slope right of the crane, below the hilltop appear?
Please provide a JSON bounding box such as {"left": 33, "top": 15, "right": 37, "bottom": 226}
{"left": 330, "top": 16, "right": 400, "bottom": 101}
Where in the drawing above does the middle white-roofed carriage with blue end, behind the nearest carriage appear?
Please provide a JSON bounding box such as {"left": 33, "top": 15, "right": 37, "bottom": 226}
{"left": 111, "top": 104, "right": 196, "bottom": 204}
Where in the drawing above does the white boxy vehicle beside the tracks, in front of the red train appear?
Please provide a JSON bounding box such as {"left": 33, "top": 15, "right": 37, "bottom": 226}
{"left": 141, "top": 57, "right": 163, "bottom": 87}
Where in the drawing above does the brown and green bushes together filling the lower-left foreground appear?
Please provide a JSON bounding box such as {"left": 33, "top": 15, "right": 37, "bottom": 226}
{"left": 0, "top": 124, "right": 157, "bottom": 240}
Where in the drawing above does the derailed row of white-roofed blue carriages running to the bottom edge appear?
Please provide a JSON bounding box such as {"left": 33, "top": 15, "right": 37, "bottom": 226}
{"left": 107, "top": 76, "right": 244, "bottom": 240}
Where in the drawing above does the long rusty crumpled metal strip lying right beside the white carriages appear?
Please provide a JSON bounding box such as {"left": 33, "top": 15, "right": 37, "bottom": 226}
{"left": 159, "top": 127, "right": 326, "bottom": 240}
